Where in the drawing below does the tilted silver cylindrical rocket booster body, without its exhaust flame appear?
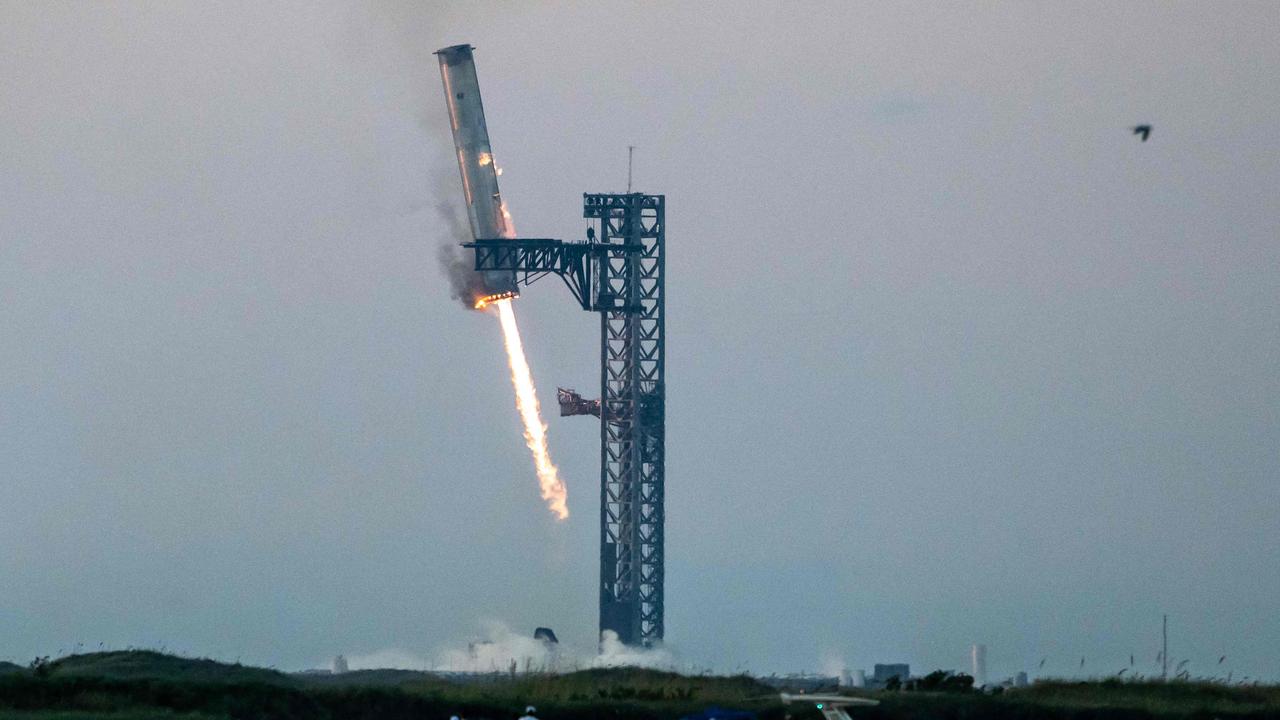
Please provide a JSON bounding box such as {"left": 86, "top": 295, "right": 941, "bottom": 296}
{"left": 435, "top": 45, "right": 518, "bottom": 302}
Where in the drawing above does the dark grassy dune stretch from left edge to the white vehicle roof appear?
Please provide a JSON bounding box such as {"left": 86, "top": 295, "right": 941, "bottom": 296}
{"left": 0, "top": 652, "right": 783, "bottom": 720}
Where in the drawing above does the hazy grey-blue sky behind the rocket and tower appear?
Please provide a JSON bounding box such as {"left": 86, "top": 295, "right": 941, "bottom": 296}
{"left": 0, "top": 1, "right": 1280, "bottom": 679}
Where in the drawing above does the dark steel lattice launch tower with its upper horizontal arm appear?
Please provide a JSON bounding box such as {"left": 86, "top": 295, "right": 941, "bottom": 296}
{"left": 466, "top": 192, "right": 666, "bottom": 646}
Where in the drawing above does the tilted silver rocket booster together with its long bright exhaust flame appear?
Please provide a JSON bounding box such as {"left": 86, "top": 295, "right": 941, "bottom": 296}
{"left": 436, "top": 45, "right": 568, "bottom": 520}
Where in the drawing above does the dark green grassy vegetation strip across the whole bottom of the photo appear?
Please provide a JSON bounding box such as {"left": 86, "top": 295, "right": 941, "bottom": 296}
{"left": 0, "top": 652, "right": 1280, "bottom": 720}
